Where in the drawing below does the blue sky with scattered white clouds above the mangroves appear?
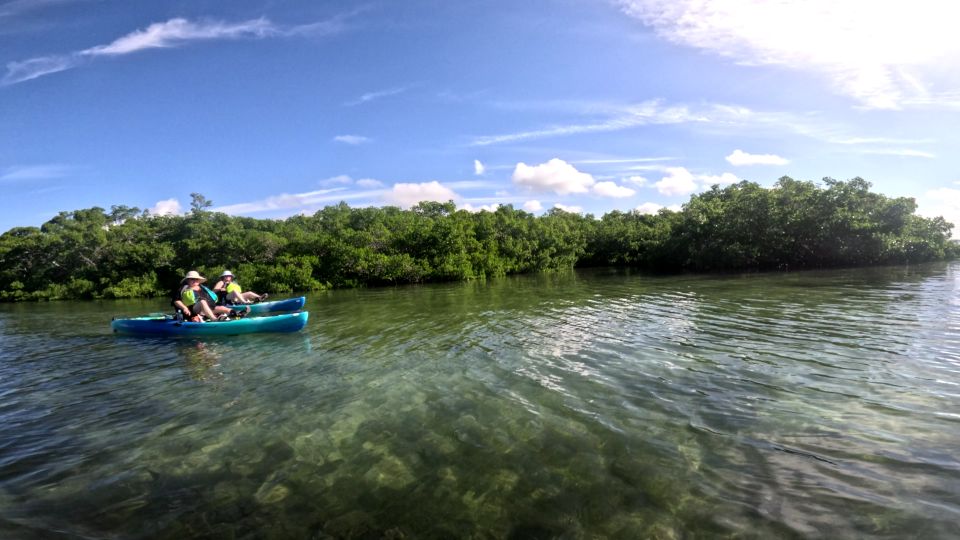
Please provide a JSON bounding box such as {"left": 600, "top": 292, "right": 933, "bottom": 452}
{"left": 0, "top": 0, "right": 960, "bottom": 235}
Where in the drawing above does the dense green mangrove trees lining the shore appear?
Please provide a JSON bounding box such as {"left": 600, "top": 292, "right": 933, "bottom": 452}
{"left": 0, "top": 177, "right": 960, "bottom": 302}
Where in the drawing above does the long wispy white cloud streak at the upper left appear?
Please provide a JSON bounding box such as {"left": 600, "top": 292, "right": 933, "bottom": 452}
{"left": 0, "top": 14, "right": 352, "bottom": 86}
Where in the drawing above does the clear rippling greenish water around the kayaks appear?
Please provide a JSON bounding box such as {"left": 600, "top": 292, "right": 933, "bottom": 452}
{"left": 0, "top": 264, "right": 960, "bottom": 539}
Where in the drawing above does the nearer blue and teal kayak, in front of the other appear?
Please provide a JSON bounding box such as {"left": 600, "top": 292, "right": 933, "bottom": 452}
{"left": 110, "top": 311, "right": 308, "bottom": 336}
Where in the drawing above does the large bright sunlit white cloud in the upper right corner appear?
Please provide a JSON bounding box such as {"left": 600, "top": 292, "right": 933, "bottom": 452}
{"left": 619, "top": 0, "right": 960, "bottom": 109}
